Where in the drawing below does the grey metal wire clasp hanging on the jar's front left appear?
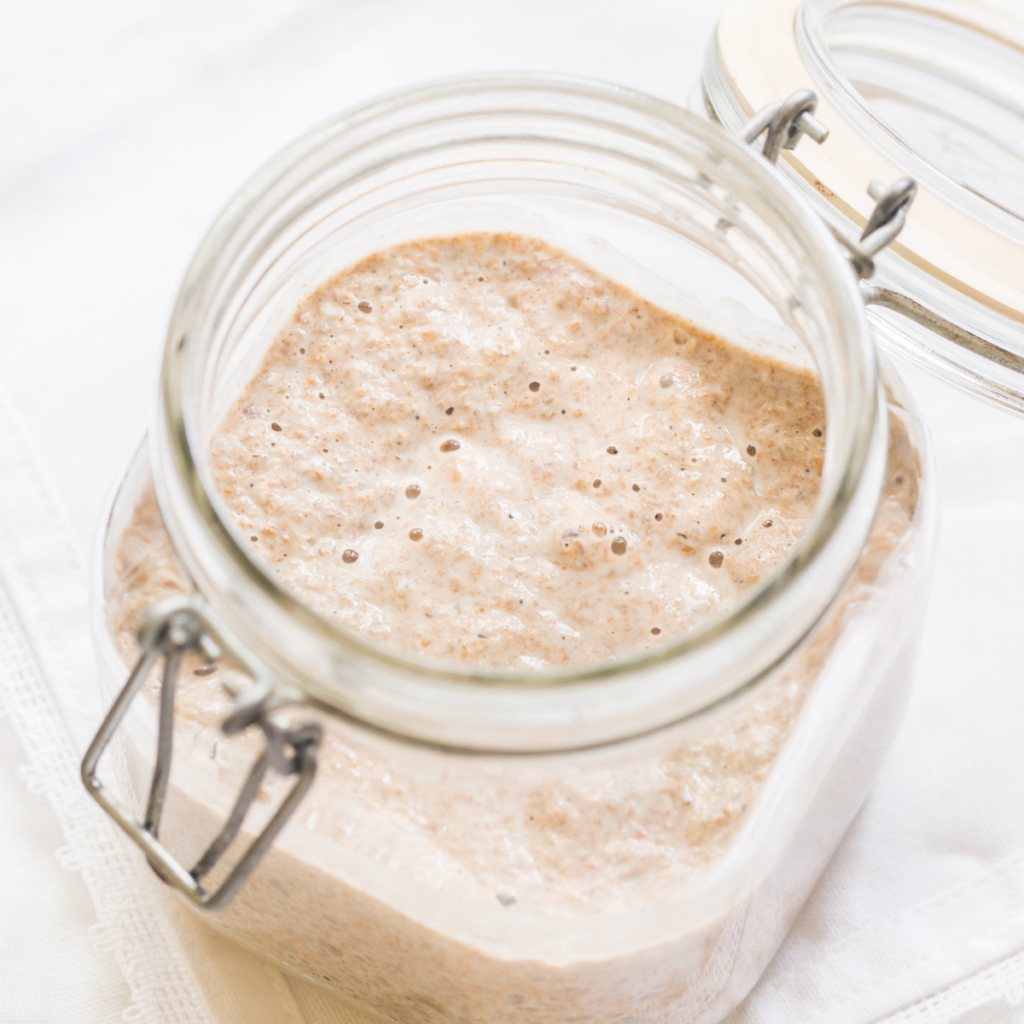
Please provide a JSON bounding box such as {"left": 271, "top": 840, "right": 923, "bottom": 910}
{"left": 82, "top": 597, "right": 323, "bottom": 910}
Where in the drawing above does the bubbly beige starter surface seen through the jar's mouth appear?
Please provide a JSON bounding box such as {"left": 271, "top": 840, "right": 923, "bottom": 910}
{"left": 211, "top": 233, "right": 824, "bottom": 670}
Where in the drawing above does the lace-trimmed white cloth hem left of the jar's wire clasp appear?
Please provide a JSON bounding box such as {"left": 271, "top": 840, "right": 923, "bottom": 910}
{"left": 0, "top": 382, "right": 213, "bottom": 1024}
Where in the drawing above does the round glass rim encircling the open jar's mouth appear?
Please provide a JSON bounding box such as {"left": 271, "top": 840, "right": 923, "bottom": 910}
{"left": 154, "top": 74, "right": 887, "bottom": 746}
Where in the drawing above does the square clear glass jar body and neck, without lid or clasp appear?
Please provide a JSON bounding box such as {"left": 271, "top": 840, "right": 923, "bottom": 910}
{"left": 95, "top": 76, "right": 933, "bottom": 1024}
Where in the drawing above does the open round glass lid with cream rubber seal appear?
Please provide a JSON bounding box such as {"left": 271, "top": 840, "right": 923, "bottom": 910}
{"left": 702, "top": 0, "right": 1024, "bottom": 414}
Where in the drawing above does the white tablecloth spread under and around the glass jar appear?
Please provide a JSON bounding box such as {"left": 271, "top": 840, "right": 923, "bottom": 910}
{"left": 0, "top": 0, "right": 1024, "bottom": 1024}
